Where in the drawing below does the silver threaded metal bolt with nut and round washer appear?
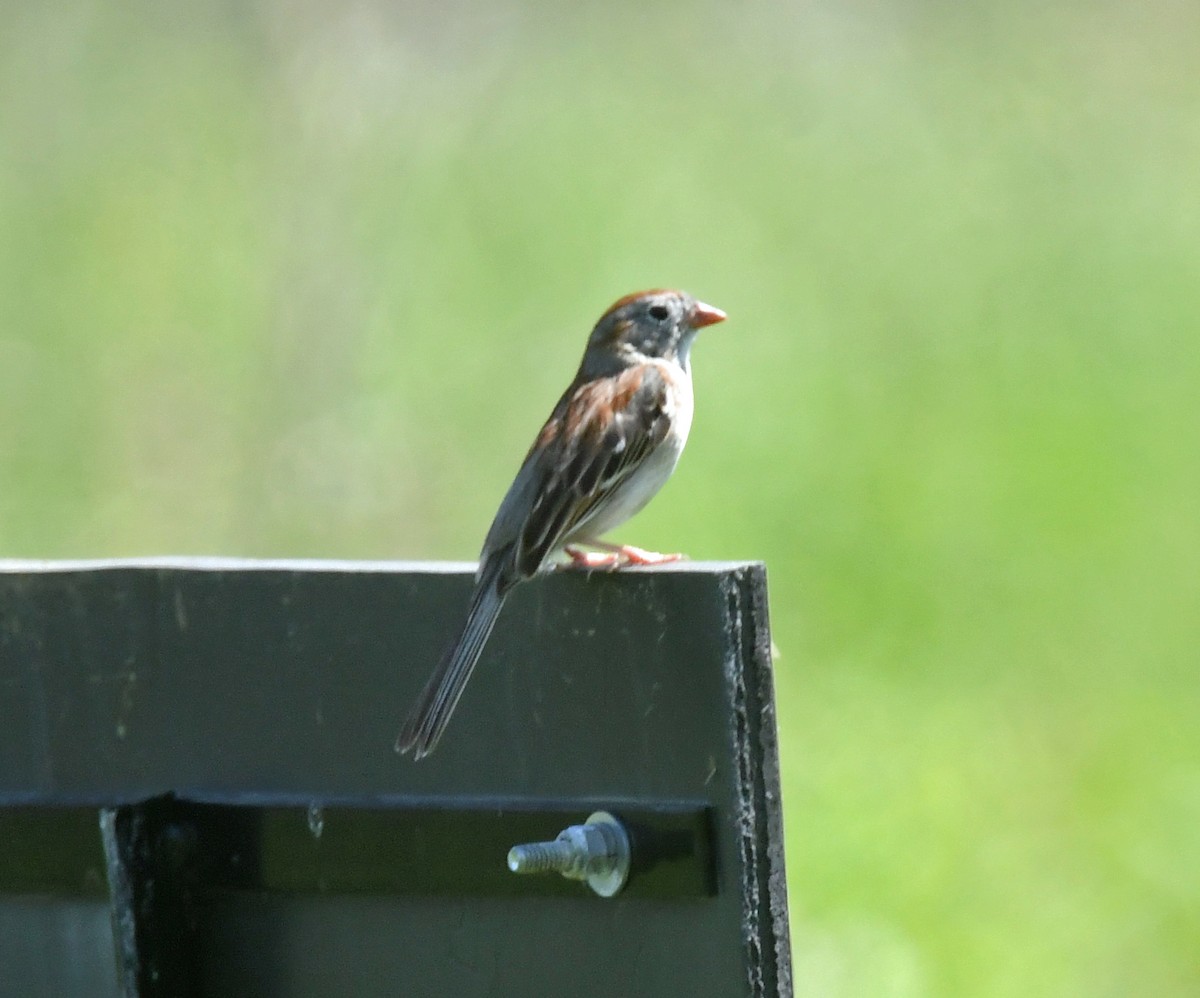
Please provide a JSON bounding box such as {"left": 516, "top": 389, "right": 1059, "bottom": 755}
{"left": 509, "top": 811, "right": 629, "bottom": 897}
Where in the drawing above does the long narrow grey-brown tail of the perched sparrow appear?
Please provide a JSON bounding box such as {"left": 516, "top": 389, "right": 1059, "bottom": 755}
{"left": 396, "top": 558, "right": 506, "bottom": 759}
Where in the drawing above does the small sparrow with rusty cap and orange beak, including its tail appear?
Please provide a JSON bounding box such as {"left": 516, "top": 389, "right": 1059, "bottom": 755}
{"left": 396, "top": 290, "right": 725, "bottom": 759}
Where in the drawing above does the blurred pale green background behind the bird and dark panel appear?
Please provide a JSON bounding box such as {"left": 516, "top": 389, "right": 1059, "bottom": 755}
{"left": 0, "top": 0, "right": 1200, "bottom": 998}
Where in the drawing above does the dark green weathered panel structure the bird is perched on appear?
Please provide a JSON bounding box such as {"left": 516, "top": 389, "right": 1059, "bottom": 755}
{"left": 0, "top": 559, "right": 791, "bottom": 998}
